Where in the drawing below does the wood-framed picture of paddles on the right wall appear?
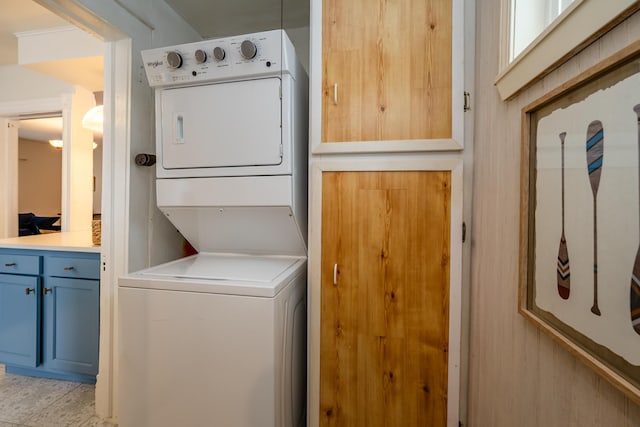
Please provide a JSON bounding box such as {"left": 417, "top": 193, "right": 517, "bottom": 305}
{"left": 519, "top": 38, "right": 640, "bottom": 403}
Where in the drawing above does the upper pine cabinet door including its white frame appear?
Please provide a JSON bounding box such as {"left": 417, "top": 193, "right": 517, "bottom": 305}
{"left": 311, "top": 0, "right": 464, "bottom": 153}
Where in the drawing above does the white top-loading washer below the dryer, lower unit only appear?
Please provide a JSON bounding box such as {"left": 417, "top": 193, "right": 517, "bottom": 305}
{"left": 119, "top": 254, "right": 306, "bottom": 427}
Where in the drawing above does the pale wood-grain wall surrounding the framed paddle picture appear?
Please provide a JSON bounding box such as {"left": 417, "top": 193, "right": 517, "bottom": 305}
{"left": 465, "top": 4, "right": 640, "bottom": 427}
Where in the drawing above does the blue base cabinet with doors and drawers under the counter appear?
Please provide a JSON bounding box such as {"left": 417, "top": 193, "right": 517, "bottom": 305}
{"left": 0, "top": 249, "right": 100, "bottom": 383}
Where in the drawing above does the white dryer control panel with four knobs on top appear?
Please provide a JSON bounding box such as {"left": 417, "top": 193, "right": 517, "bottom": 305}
{"left": 142, "top": 30, "right": 296, "bottom": 87}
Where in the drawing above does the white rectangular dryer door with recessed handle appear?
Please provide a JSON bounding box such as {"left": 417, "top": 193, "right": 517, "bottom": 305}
{"left": 160, "top": 78, "right": 282, "bottom": 169}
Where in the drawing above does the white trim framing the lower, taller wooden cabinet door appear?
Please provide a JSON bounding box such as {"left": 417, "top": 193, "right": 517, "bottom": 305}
{"left": 307, "top": 154, "right": 463, "bottom": 427}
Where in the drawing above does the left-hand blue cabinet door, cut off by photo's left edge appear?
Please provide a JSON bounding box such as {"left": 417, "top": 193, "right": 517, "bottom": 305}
{"left": 0, "top": 274, "right": 40, "bottom": 367}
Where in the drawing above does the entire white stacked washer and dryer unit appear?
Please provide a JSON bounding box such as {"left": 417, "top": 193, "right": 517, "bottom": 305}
{"left": 118, "top": 30, "right": 308, "bottom": 427}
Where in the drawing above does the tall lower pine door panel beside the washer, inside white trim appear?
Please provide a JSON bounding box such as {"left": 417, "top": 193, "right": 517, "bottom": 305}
{"left": 319, "top": 171, "right": 451, "bottom": 427}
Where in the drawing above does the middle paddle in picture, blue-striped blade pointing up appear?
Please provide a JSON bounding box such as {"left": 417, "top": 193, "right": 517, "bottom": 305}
{"left": 587, "top": 120, "right": 604, "bottom": 316}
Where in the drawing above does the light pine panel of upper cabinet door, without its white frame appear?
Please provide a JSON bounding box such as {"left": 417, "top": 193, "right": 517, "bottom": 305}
{"left": 321, "top": 0, "right": 452, "bottom": 142}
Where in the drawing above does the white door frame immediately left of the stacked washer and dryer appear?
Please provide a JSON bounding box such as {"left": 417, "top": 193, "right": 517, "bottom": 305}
{"left": 34, "top": 0, "right": 142, "bottom": 419}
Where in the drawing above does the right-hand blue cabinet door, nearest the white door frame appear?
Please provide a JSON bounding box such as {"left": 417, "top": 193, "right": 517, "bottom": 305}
{"left": 42, "top": 277, "right": 100, "bottom": 375}
